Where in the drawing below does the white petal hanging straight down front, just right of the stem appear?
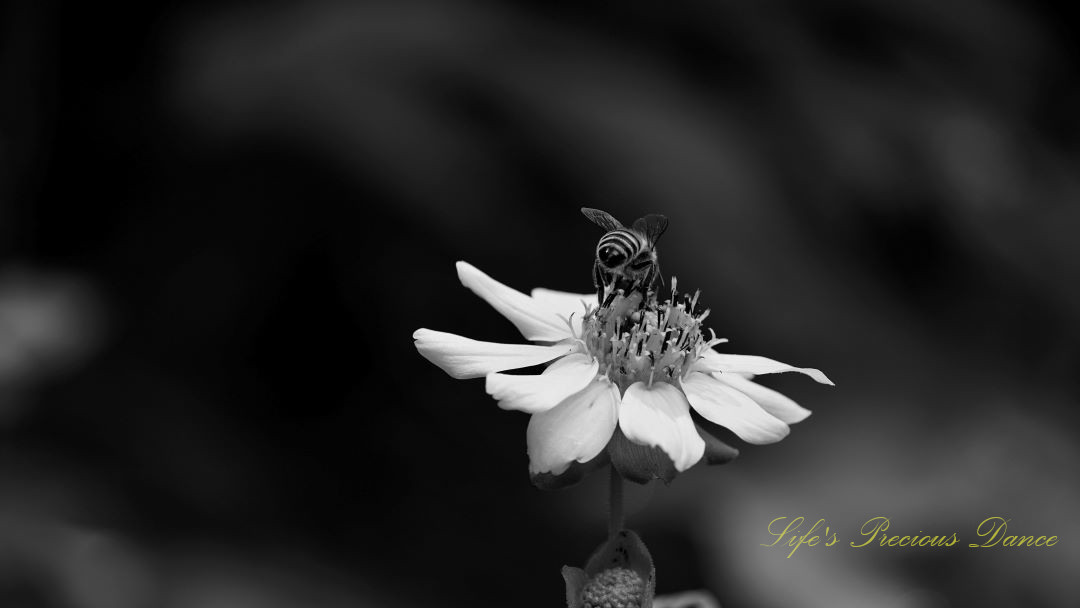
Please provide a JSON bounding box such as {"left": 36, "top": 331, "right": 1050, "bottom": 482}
{"left": 619, "top": 382, "right": 705, "bottom": 472}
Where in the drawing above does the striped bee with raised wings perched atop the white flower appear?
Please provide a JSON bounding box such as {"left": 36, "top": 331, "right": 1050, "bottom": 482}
{"left": 581, "top": 207, "right": 667, "bottom": 306}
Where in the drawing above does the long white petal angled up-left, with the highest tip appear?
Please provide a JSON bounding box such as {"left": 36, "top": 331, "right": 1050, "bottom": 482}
{"left": 458, "top": 261, "right": 573, "bottom": 342}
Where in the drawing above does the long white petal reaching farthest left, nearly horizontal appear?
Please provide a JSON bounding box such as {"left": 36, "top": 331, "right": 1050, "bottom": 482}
{"left": 413, "top": 329, "right": 579, "bottom": 378}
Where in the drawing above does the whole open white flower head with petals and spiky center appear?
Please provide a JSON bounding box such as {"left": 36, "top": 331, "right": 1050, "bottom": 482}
{"left": 413, "top": 261, "right": 833, "bottom": 482}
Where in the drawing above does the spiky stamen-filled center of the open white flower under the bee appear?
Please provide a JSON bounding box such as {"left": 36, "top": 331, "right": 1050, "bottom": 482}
{"left": 582, "top": 278, "right": 719, "bottom": 392}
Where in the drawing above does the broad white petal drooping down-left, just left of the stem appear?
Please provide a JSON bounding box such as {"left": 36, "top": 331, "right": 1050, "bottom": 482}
{"left": 526, "top": 379, "right": 619, "bottom": 475}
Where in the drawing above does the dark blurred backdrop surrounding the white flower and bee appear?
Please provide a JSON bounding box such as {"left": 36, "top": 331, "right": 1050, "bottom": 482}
{"left": 0, "top": 0, "right": 1080, "bottom": 608}
